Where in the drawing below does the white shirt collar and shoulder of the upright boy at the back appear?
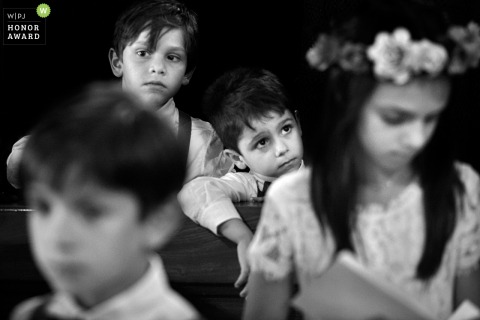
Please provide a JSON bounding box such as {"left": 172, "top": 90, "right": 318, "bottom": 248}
{"left": 158, "top": 98, "right": 233, "bottom": 182}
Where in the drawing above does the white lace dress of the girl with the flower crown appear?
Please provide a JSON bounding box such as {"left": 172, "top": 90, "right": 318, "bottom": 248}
{"left": 249, "top": 164, "right": 480, "bottom": 319}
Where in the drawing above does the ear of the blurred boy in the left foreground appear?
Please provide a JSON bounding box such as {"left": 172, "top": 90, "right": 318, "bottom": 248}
{"left": 142, "top": 194, "right": 184, "bottom": 250}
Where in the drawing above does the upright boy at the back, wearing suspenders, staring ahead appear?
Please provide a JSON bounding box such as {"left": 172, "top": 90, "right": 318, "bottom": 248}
{"left": 7, "top": 0, "right": 232, "bottom": 188}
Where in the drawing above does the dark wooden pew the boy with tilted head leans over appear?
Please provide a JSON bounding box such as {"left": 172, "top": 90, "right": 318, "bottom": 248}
{"left": 0, "top": 203, "right": 261, "bottom": 319}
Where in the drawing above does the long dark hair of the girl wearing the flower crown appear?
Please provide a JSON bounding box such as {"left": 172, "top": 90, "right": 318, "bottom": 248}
{"left": 311, "top": 0, "right": 463, "bottom": 279}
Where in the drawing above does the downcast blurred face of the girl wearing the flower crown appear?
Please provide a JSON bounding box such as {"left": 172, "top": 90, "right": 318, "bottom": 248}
{"left": 358, "top": 78, "right": 450, "bottom": 173}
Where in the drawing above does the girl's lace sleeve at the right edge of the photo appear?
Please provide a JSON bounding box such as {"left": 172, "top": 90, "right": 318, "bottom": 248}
{"left": 458, "top": 166, "right": 480, "bottom": 273}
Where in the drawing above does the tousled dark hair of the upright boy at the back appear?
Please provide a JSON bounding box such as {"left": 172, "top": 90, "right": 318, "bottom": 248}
{"left": 112, "top": 0, "right": 198, "bottom": 73}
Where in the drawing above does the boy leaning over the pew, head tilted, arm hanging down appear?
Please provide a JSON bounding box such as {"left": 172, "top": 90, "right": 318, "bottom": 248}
{"left": 179, "top": 67, "right": 303, "bottom": 296}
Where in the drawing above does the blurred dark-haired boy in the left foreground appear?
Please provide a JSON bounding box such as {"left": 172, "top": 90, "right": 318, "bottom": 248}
{"left": 11, "top": 84, "right": 200, "bottom": 320}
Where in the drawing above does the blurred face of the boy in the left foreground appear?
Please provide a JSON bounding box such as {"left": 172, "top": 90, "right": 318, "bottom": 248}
{"left": 27, "top": 183, "right": 154, "bottom": 306}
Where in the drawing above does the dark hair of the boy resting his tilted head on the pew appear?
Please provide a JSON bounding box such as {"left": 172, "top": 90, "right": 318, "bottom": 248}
{"left": 203, "top": 67, "right": 290, "bottom": 153}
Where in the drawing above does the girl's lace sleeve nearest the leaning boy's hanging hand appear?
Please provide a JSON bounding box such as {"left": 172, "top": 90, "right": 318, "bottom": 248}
{"left": 248, "top": 195, "right": 292, "bottom": 280}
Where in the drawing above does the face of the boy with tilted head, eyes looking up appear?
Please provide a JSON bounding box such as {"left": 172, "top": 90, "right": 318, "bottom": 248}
{"left": 238, "top": 110, "right": 303, "bottom": 178}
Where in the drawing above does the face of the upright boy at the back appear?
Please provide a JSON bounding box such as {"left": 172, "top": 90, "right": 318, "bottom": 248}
{"left": 120, "top": 29, "right": 189, "bottom": 109}
